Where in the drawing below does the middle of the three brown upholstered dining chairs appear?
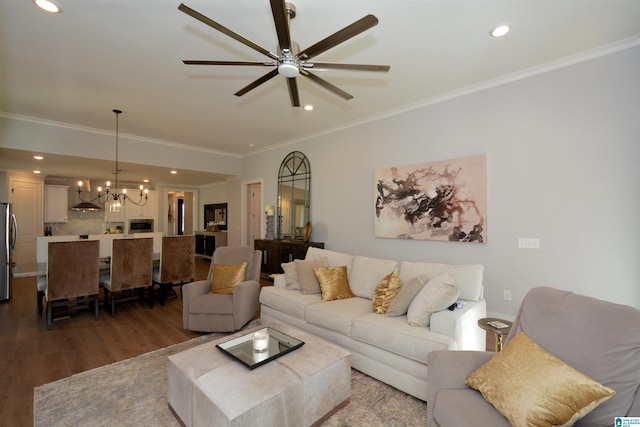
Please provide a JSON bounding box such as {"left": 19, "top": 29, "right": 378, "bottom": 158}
{"left": 102, "top": 238, "right": 153, "bottom": 316}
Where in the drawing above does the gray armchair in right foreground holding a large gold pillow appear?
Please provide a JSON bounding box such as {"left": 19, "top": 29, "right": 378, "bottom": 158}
{"left": 427, "top": 287, "right": 640, "bottom": 427}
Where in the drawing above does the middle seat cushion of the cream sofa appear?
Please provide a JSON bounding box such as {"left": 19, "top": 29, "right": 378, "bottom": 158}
{"left": 306, "top": 298, "right": 372, "bottom": 337}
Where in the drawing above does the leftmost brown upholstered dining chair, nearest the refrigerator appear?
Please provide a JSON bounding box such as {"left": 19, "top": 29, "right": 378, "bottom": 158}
{"left": 45, "top": 240, "right": 100, "bottom": 329}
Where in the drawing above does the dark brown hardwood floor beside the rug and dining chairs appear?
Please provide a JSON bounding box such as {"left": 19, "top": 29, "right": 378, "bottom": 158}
{"left": 0, "top": 258, "right": 210, "bottom": 426}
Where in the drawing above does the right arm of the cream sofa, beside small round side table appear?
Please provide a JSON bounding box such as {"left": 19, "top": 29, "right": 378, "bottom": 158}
{"left": 429, "top": 300, "right": 487, "bottom": 351}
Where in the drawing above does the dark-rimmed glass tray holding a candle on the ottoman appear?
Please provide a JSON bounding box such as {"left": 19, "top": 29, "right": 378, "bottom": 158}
{"left": 216, "top": 327, "right": 304, "bottom": 369}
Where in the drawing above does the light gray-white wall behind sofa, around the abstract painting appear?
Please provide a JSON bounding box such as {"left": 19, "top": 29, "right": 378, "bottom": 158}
{"left": 241, "top": 47, "right": 640, "bottom": 316}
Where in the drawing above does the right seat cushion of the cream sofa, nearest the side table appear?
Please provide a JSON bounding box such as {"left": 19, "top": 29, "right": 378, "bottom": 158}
{"left": 351, "top": 313, "right": 455, "bottom": 363}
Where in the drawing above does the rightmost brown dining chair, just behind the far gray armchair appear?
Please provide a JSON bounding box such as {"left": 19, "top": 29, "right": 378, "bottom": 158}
{"left": 152, "top": 235, "right": 196, "bottom": 305}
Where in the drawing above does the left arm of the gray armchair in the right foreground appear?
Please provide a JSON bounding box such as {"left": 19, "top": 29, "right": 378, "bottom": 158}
{"left": 427, "top": 350, "right": 495, "bottom": 425}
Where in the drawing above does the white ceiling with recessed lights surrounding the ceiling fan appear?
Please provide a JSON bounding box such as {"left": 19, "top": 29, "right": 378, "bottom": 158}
{"left": 0, "top": 0, "right": 640, "bottom": 184}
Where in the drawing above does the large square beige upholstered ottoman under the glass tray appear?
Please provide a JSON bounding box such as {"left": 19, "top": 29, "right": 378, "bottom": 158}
{"left": 167, "top": 322, "right": 351, "bottom": 426}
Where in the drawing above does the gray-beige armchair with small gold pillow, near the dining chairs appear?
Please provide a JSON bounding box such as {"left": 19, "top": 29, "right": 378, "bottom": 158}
{"left": 182, "top": 246, "right": 262, "bottom": 332}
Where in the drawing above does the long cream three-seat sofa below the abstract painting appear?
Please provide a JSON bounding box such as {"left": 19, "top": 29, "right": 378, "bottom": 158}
{"left": 260, "top": 248, "right": 486, "bottom": 401}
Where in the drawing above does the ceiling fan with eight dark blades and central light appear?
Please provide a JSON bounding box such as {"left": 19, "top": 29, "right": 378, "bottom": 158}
{"left": 178, "top": 0, "right": 390, "bottom": 107}
